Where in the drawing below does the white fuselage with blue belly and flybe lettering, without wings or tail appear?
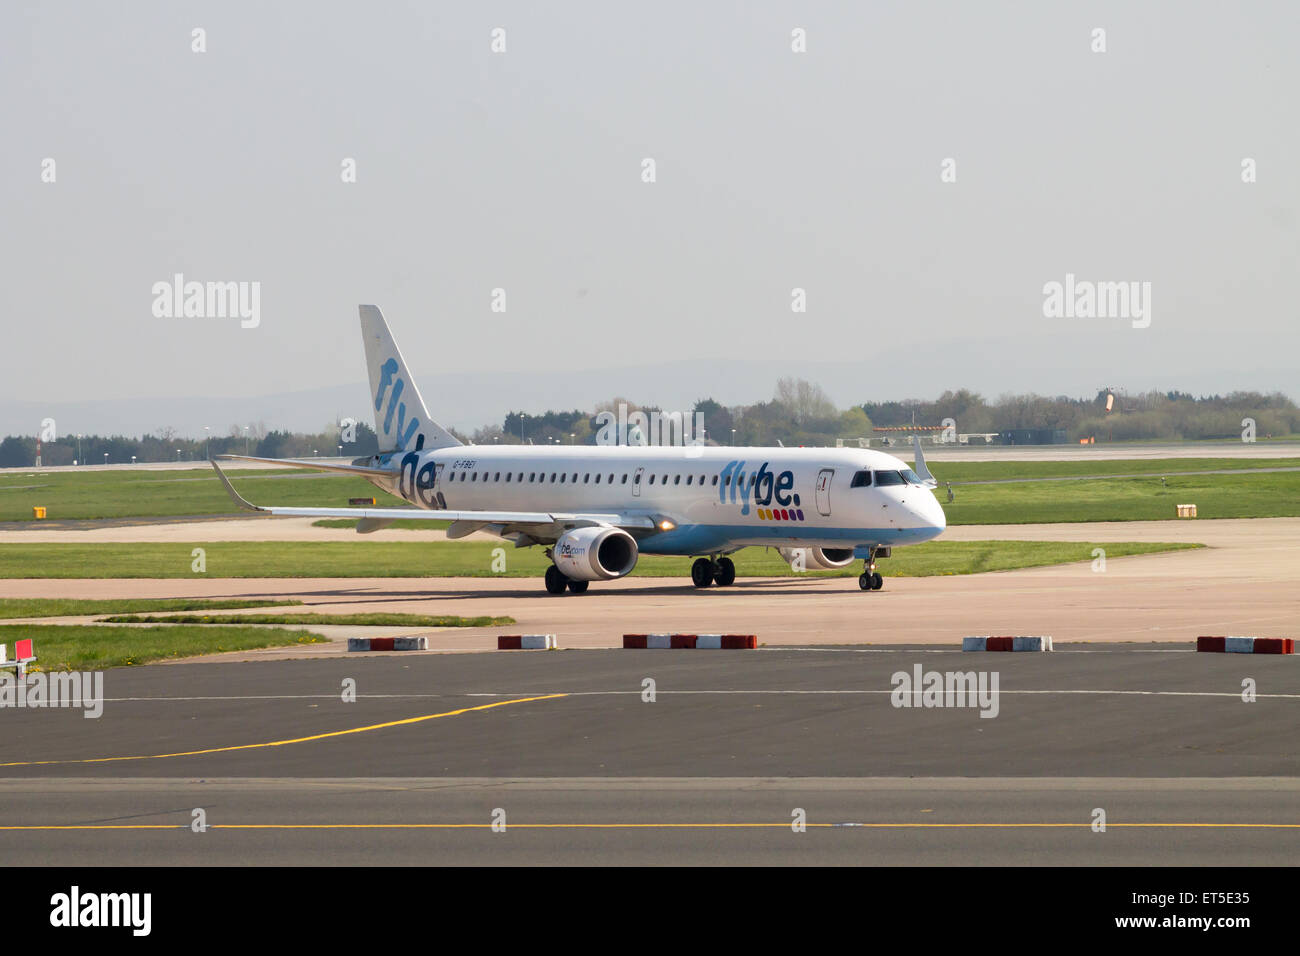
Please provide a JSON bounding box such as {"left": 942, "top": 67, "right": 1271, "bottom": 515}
{"left": 372, "top": 445, "right": 946, "bottom": 554}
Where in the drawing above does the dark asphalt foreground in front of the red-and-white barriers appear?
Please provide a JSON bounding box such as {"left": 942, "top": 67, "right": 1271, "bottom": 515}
{"left": 0, "top": 644, "right": 1300, "bottom": 865}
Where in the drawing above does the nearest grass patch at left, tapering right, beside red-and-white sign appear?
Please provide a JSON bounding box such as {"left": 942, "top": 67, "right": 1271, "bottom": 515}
{"left": 0, "top": 624, "right": 328, "bottom": 671}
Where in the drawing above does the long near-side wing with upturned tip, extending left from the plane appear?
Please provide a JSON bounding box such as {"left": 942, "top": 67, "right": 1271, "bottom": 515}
{"left": 212, "top": 459, "right": 673, "bottom": 537}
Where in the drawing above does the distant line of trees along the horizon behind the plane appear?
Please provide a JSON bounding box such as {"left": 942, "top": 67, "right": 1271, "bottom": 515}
{"left": 0, "top": 378, "right": 1300, "bottom": 467}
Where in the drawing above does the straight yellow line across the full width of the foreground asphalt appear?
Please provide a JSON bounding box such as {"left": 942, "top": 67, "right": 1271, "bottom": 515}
{"left": 0, "top": 822, "right": 1300, "bottom": 830}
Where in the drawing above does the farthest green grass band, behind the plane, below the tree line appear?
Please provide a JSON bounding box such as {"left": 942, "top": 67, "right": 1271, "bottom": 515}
{"left": 0, "top": 458, "right": 1300, "bottom": 531}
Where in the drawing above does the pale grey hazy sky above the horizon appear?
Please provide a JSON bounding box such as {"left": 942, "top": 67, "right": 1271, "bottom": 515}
{"left": 0, "top": 1, "right": 1300, "bottom": 429}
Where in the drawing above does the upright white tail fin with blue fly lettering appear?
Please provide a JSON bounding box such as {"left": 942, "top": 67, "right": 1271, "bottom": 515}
{"left": 360, "top": 306, "right": 460, "bottom": 454}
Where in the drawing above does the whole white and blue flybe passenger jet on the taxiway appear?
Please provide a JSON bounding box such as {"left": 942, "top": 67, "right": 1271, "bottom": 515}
{"left": 212, "top": 306, "right": 946, "bottom": 594}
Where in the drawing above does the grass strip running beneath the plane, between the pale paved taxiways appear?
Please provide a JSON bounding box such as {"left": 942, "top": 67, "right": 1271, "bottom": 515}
{"left": 0, "top": 541, "right": 1200, "bottom": 578}
